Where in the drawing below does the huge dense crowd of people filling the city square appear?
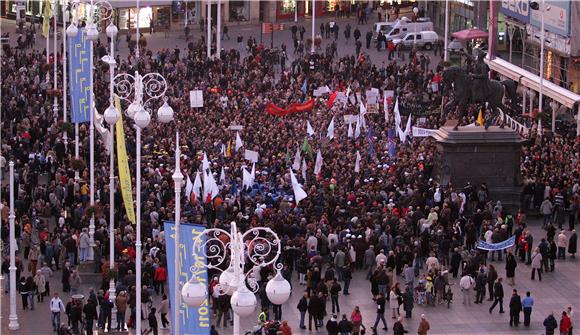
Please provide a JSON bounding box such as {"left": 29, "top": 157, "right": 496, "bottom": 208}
{"left": 1, "top": 5, "right": 580, "bottom": 335}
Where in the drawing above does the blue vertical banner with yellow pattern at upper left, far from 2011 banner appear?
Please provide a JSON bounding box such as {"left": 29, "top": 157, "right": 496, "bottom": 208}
{"left": 68, "top": 29, "right": 92, "bottom": 123}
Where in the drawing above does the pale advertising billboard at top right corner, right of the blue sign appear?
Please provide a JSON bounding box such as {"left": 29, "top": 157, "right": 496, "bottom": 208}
{"left": 530, "top": 0, "right": 571, "bottom": 37}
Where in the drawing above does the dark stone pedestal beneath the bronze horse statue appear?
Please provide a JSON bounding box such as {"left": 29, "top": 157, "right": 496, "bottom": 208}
{"left": 433, "top": 126, "right": 524, "bottom": 207}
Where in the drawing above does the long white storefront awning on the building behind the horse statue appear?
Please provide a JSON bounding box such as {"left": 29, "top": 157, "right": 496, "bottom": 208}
{"left": 485, "top": 57, "right": 580, "bottom": 108}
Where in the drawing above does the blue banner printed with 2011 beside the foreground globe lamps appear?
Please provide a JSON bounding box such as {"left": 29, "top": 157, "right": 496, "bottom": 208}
{"left": 164, "top": 221, "right": 211, "bottom": 335}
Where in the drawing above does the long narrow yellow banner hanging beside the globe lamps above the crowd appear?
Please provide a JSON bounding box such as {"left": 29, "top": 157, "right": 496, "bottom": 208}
{"left": 115, "top": 96, "right": 135, "bottom": 224}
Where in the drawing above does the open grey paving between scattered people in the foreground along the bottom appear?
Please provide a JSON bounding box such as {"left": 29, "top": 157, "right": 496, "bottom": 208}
{"left": 0, "top": 220, "right": 580, "bottom": 335}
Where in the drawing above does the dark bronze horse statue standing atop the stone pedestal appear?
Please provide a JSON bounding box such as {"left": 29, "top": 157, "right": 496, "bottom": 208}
{"left": 443, "top": 64, "right": 518, "bottom": 130}
